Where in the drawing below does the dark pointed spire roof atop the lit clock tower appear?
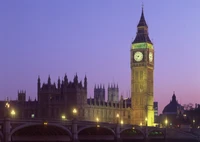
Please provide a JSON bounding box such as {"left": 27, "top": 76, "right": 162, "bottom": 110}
{"left": 132, "top": 7, "right": 152, "bottom": 44}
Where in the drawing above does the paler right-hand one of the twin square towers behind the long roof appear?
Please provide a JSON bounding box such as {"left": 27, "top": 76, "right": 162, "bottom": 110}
{"left": 108, "top": 84, "right": 119, "bottom": 103}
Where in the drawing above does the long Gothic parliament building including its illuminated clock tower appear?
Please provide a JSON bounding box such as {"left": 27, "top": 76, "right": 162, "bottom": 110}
{"left": 0, "top": 9, "right": 154, "bottom": 126}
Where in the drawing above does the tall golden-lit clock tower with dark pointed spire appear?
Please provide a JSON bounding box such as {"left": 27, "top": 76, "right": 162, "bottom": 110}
{"left": 131, "top": 8, "right": 154, "bottom": 126}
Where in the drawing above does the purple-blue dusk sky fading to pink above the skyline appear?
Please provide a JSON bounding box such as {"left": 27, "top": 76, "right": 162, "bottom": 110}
{"left": 0, "top": 0, "right": 200, "bottom": 112}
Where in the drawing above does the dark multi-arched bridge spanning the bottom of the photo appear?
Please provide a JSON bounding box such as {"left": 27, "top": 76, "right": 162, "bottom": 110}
{"left": 0, "top": 118, "right": 199, "bottom": 142}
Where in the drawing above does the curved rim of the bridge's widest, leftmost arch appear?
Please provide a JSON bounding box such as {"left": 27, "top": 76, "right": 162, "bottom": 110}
{"left": 10, "top": 123, "right": 72, "bottom": 138}
